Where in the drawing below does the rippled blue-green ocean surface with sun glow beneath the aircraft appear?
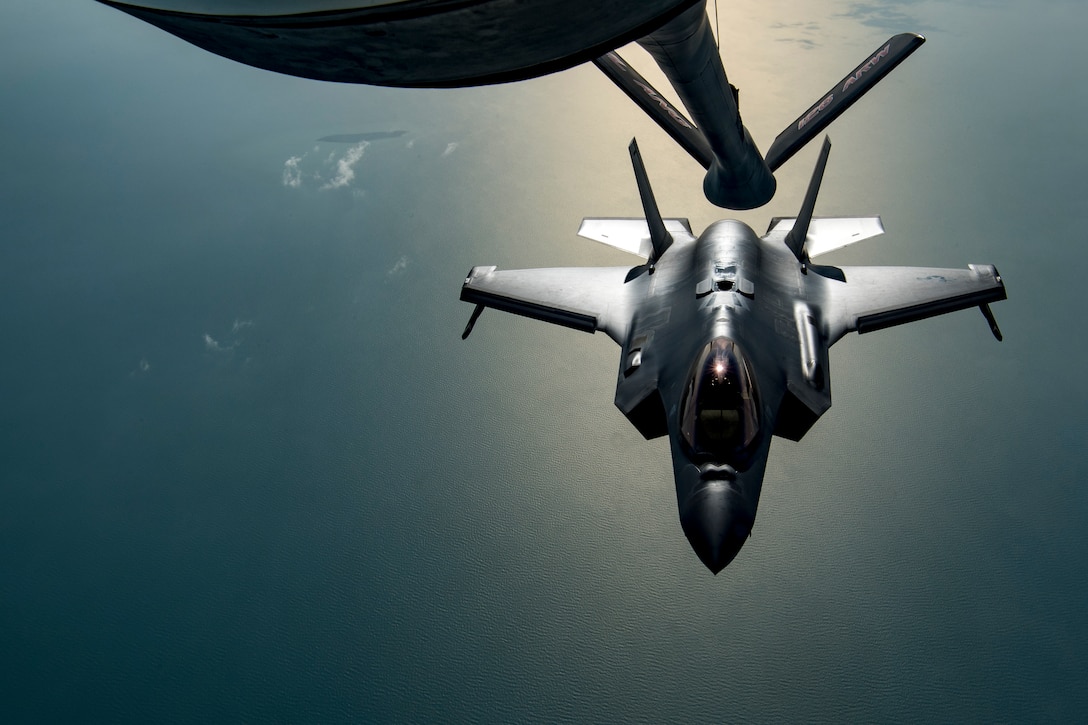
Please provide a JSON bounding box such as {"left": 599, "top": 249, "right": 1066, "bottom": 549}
{"left": 0, "top": 0, "right": 1088, "bottom": 723}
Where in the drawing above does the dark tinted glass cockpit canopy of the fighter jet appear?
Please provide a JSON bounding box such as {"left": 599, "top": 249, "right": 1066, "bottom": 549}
{"left": 680, "top": 337, "right": 759, "bottom": 470}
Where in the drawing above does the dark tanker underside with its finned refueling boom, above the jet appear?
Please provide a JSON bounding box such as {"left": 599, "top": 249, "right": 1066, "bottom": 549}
{"left": 99, "top": 0, "right": 925, "bottom": 209}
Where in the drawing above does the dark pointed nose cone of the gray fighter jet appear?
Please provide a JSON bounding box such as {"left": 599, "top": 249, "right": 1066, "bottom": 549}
{"left": 680, "top": 481, "right": 754, "bottom": 574}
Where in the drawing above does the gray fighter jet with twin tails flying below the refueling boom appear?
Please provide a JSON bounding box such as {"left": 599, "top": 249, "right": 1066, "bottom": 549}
{"left": 460, "top": 138, "right": 1005, "bottom": 574}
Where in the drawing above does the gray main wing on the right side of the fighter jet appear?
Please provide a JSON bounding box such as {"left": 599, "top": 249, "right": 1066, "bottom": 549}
{"left": 822, "top": 265, "right": 1005, "bottom": 345}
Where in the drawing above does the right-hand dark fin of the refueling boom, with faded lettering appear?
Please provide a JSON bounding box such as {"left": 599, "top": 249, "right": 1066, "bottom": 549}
{"left": 766, "top": 33, "right": 926, "bottom": 171}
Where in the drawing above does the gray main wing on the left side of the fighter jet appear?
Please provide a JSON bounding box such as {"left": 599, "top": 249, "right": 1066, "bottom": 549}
{"left": 461, "top": 267, "right": 631, "bottom": 343}
